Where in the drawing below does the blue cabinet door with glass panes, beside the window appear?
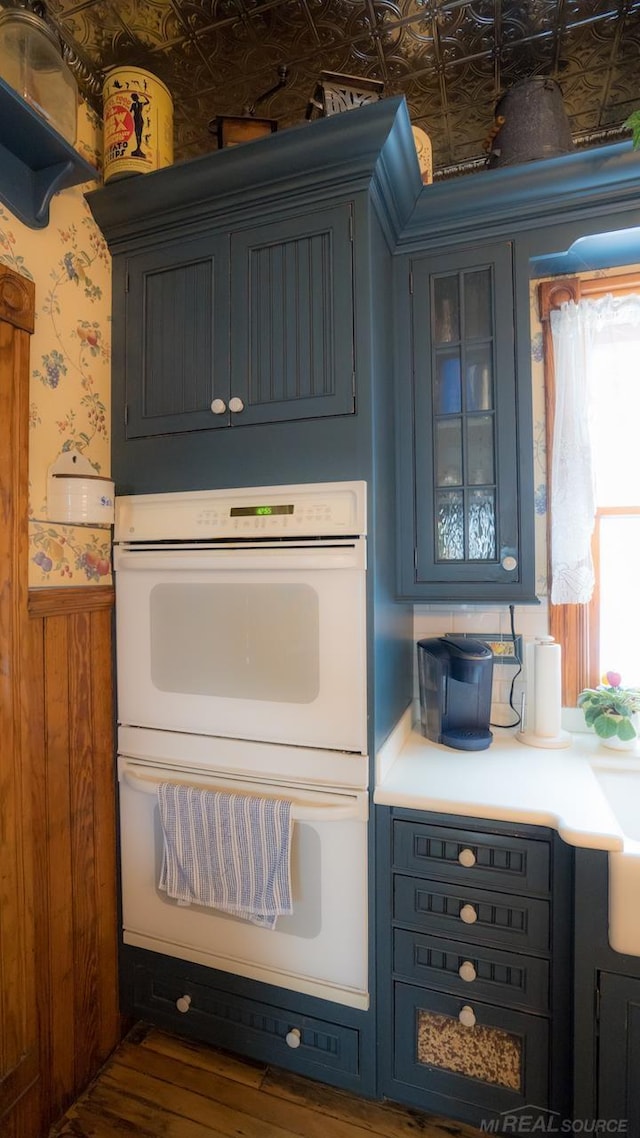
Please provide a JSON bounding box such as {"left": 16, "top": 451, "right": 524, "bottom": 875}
{"left": 399, "top": 242, "right": 532, "bottom": 600}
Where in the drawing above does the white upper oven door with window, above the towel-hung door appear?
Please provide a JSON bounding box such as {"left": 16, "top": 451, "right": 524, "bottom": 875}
{"left": 115, "top": 539, "right": 367, "bottom": 753}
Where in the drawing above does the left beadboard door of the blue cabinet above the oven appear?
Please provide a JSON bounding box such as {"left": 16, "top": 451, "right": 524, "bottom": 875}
{"left": 125, "top": 234, "right": 229, "bottom": 438}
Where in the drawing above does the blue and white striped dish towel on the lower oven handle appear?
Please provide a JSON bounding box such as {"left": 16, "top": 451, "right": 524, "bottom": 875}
{"left": 158, "top": 783, "right": 293, "bottom": 929}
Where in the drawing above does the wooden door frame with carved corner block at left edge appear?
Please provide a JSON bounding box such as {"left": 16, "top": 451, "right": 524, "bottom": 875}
{"left": 0, "top": 265, "right": 41, "bottom": 1136}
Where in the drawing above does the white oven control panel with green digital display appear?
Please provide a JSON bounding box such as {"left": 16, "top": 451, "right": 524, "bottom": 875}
{"left": 115, "top": 483, "right": 367, "bottom": 542}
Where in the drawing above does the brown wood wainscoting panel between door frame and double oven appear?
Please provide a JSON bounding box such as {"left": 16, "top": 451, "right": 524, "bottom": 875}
{"left": 28, "top": 588, "right": 123, "bottom": 1121}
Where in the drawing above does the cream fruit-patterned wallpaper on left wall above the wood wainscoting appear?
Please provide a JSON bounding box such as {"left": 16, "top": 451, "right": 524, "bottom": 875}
{"left": 0, "top": 105, "right": 112, "bottom": 587}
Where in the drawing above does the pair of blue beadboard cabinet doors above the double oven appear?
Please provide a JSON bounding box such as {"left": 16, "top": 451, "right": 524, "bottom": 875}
{"left": 116, "top": 203, "right": 355, "bottom": 439}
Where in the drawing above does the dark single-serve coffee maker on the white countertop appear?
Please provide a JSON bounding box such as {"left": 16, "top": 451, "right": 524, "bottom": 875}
{"left": 418, "top": 636, "right": 493, "bottom": 751}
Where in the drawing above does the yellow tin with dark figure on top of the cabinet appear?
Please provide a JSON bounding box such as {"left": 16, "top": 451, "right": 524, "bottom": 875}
{"left": 102, "top": 67, "right": 173, "bottom": 182}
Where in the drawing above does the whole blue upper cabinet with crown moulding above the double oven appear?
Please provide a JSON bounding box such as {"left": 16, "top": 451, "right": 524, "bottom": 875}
{"left": 88, "top": 99, "right": 421, "bottom": 493}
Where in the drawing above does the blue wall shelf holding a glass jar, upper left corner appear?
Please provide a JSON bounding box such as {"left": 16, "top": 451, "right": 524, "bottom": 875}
{"left": 0, "top": 79, "right": 98, "bottom": 229}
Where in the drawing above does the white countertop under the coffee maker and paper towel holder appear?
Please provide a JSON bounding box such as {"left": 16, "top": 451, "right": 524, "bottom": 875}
{"left": 374, "top": 709, "right": 624, "bottom": 850}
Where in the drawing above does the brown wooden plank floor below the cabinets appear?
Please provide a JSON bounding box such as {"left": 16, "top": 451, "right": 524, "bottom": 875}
{"left": 49, "top": 1025, "right": 479, "bottom": 1138}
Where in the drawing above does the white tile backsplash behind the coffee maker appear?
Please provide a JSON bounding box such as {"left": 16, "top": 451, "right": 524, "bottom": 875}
{"left": 413, "top": 597, "right": 549, "bottom": 726}
